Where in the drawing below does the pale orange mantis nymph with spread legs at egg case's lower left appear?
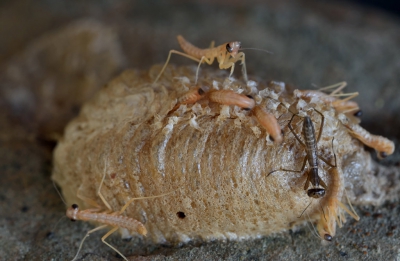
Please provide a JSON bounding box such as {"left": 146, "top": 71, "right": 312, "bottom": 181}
{"left": 66, "top": 162, "right": 173, "bottom": 261}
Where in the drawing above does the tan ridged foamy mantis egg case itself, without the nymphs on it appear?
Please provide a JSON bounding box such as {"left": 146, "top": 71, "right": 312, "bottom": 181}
{"left": 52, "top": 66, "right": 392, "bottom": 244}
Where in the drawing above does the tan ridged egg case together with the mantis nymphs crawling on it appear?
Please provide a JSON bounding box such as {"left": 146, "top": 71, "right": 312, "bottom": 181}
{"left": 52, "top": 35, "right": 394, "bottom": 256}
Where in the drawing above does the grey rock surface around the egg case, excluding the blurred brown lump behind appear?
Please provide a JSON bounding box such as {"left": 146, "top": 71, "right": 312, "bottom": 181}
{"left": 0, "top": 0, "right": 400, "bottom": 260}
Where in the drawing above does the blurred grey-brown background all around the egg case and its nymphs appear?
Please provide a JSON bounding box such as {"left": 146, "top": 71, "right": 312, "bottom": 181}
{"left": 0, "top": 0, "right": 400, "bottom": 260}
